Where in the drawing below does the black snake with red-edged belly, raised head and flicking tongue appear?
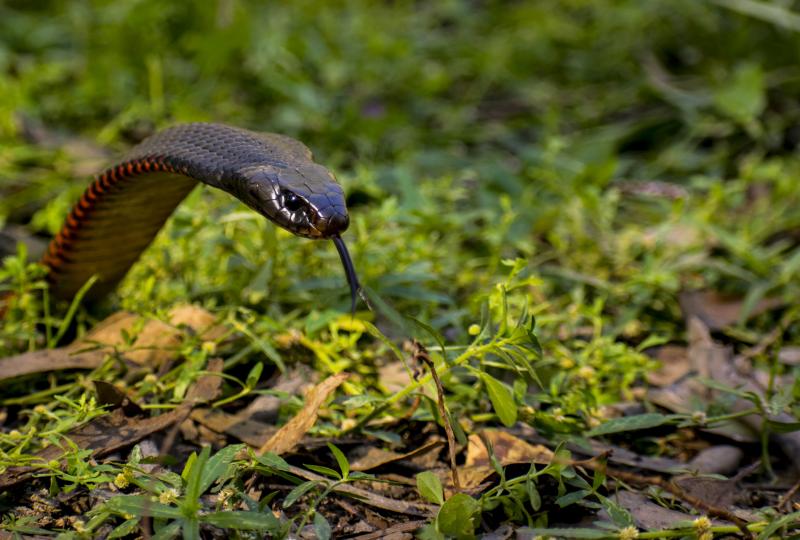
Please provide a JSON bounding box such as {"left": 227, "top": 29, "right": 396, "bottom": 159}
{"left": 42, "top": 123, "right": 360, "bottom": 311}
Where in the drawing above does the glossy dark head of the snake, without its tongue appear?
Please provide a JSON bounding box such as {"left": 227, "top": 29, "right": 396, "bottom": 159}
{"left": 240, "top": 162, "right": 350, "bottom": 238}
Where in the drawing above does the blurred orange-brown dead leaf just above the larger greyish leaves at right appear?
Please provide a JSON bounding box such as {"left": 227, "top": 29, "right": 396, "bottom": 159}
{"left": 679, "top": 291, "right": 785, "bottom": 330}
